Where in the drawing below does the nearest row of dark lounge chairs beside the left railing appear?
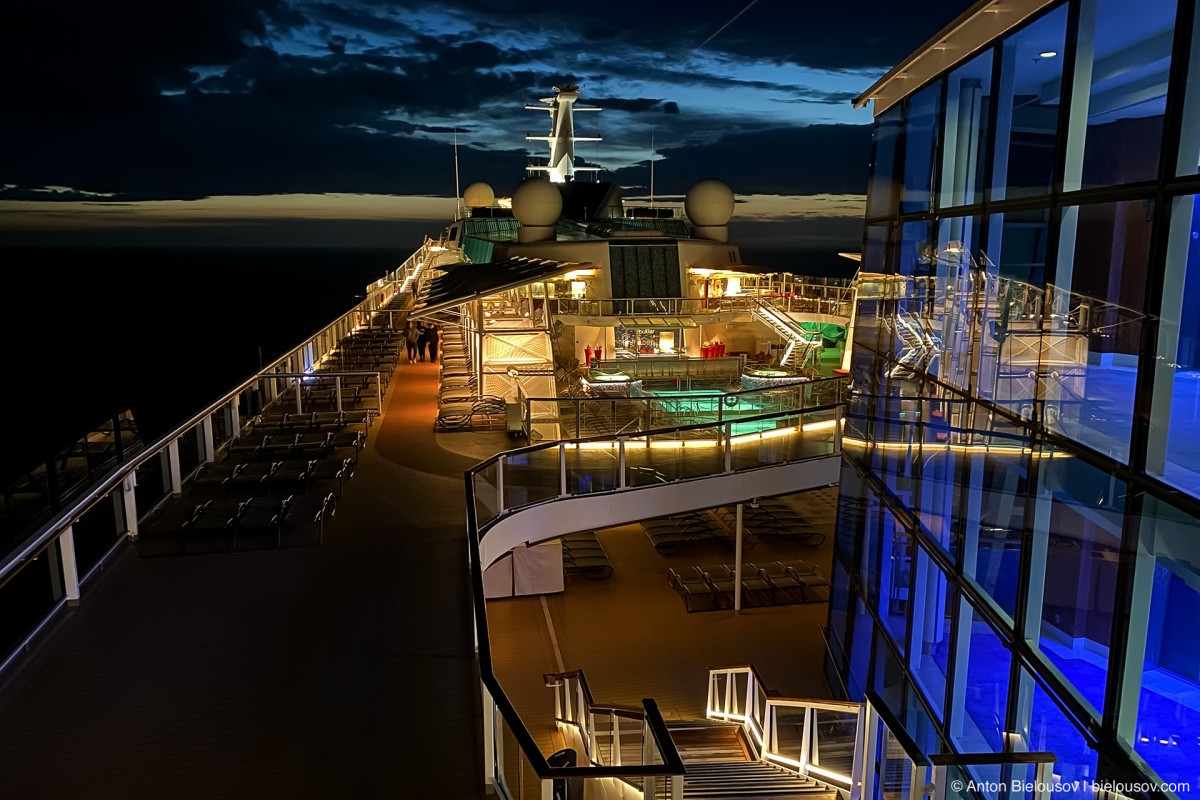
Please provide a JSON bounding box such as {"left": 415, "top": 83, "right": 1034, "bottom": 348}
{"left": 138, "top": 493, "right": 337, "bottom": 555}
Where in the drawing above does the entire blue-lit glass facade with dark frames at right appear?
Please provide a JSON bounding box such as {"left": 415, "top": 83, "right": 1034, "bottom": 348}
{"left": 830, "top": 0, "right": 1200, "bottom": 799}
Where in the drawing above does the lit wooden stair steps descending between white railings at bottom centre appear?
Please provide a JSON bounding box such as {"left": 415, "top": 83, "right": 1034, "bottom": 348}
{"left": 667, "top": 720, "right": 836, "bottom": 800}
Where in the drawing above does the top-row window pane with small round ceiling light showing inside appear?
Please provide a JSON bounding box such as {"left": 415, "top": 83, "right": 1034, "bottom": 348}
{"left": 991, "top": 5, "right": 1067, "bottom": 200}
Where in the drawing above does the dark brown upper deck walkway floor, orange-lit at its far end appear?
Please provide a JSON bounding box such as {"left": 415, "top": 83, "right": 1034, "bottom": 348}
{"left": 0, "top": 363, "right": 482, "bottom": 800}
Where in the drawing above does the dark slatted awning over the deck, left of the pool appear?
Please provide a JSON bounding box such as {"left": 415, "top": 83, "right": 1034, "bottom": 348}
{"left": 408, "top": 255, "right": 595, "bottom": 319}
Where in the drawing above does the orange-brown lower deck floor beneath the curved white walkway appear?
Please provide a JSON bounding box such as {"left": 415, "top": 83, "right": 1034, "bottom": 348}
{"left": 487, "top": 488, "right": 838, "bottom": 754}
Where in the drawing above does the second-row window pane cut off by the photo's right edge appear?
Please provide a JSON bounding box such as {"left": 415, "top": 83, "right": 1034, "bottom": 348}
{"left": 1146, "top": 196, "right": 1200, "bottom": 497}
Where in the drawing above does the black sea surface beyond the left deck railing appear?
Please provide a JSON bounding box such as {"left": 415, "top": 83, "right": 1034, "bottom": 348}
{"left": 0, "top": 248, "right": 410, "bottom": 482}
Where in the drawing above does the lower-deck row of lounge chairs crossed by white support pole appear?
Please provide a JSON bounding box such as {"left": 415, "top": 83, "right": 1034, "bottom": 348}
{"left": 667, "top": 560, "right": 829, "bottom": 612}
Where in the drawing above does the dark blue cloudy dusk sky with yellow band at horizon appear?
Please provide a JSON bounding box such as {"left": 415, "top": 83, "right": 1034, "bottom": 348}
{"left": 0, "top": 0, "right": 970, "bottom": 247}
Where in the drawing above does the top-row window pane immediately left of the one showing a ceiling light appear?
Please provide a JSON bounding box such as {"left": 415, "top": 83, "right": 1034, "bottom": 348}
{"left": 938, "top": 50, "right": 992, "bottom": 207}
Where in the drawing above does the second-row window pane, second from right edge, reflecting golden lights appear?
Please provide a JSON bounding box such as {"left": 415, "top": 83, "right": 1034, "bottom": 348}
{"left": 1038, "top": 200, "right": 1153, "bottom": 461}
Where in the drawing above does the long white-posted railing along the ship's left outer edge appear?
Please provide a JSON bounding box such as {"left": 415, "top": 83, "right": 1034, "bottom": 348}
{"left": 0, "top": 241, "right": 433, "bottom": 673}
